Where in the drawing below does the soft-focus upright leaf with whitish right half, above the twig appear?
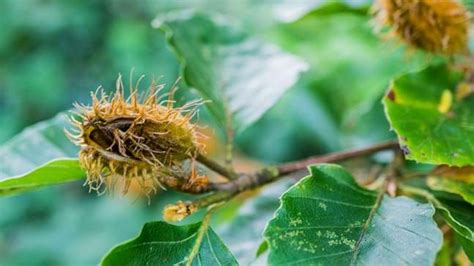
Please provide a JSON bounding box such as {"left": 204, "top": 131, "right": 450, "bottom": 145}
{"left": 154, "top": 13, "right": 308, "bottom": 132}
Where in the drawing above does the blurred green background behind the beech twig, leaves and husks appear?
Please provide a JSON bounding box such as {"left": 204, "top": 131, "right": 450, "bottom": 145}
{"left": 0, "top": 0, "right": 438, "bottom": 265}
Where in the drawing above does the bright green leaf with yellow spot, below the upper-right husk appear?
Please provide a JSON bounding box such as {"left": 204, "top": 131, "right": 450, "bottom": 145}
{"left": 383, "top": 65, "right": 474, "bottom": 166}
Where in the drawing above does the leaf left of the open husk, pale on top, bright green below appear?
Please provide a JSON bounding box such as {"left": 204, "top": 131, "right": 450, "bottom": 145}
{"left": 0, "top": 114, "right": 85, "bottom": 196}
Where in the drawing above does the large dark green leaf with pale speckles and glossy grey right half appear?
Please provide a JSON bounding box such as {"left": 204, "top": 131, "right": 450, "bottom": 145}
{"left": 265, "top": 164, "right": 442, "bottom": 265}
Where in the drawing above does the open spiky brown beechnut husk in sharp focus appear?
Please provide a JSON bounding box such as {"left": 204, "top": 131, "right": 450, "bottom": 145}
{"left": 67, "top": 77, "right": 207, "bottom": 195}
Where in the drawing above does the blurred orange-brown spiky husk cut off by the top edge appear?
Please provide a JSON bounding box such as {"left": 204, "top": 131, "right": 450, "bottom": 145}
{"left": 374, "top": 0, "right": 469, "bottom": 55}
